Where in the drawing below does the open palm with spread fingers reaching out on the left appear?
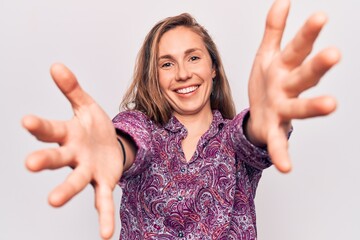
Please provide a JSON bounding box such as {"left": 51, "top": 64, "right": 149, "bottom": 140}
{"left": 22, "top": 64, "right": 123, "bottom": 239}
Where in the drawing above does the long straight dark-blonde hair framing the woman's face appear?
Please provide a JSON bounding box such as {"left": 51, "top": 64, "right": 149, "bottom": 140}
{"left": 121, "top": 13, "right": 236, "bottom": 124}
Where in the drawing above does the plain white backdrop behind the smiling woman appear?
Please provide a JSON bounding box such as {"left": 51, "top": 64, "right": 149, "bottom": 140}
{"left": 0, "top": 0, "right": 360, "bottom": 240}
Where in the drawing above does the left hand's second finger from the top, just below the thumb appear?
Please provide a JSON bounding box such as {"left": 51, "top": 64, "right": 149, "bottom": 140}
{"left": 22, "top": 115, "right": 67, "bottom": 144}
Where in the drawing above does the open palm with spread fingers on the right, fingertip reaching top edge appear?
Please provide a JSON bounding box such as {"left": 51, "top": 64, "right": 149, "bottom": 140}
{"left": 246, "top": 0, "right": 340, "bottom": 172}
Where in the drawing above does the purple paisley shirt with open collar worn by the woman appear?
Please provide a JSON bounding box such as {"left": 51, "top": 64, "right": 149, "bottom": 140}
{"left": 113, "top": 110, "right": 271, "bottom": 240}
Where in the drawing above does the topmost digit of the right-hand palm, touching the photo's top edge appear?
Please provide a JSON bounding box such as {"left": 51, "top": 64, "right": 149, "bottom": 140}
{"left": 259, "top": 0, "right": 290, "bottom": 52}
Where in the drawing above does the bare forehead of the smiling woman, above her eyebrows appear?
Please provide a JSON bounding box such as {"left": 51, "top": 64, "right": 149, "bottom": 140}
{"left": 158, "top": 26, "right": 206, "bottom": 55}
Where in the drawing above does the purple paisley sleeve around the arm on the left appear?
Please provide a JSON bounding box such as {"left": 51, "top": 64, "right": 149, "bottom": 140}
{"left": 112, "top": 111, "right": 153, "bottom": 181}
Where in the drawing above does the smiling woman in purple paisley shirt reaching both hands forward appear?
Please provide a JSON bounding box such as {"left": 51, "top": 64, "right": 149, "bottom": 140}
{"left": 23, "top": 0, "right": 340, "bottom": 239}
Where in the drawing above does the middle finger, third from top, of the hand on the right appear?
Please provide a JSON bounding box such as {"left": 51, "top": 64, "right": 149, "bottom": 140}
{"left": 284, "top": 48, "right": 341, "bottom": 97}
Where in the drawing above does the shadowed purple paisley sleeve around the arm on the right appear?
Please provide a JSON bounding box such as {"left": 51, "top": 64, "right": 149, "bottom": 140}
{"left": 230, "top": 109, "right": 272, "bottom": 170}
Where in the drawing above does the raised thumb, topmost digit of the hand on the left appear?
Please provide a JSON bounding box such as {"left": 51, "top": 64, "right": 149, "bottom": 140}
{"left": 50, "top": 63, "right": 93, "bottom": 108}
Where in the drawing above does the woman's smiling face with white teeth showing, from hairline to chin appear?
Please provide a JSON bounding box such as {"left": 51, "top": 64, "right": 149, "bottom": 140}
{"left": 157, "top": 26, "right": 216, "bottom": 116}
